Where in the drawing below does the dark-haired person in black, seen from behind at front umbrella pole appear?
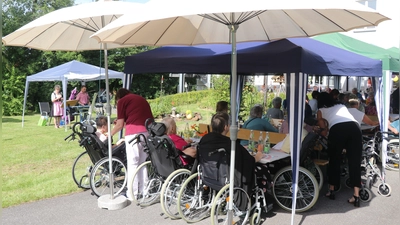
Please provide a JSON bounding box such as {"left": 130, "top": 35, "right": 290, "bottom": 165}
{"left": 197, "top": 112, "right": 272, "bottom": 197}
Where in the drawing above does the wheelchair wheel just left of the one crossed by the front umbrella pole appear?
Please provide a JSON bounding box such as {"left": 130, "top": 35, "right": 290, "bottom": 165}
{"left": 177, "top": 173, "right": 213, "bottom": 223}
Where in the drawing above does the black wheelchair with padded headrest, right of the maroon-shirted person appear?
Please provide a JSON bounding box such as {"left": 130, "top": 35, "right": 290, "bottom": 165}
{"left": 128, "top": 119, "right": 195, "bottom": 207}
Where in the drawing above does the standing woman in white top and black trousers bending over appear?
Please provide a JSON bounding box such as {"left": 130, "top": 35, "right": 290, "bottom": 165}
{"left": 317, "top": 92, "right": 362, "bottom": 207}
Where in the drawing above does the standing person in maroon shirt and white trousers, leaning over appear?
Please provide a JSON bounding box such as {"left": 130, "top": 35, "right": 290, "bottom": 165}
{"left": 110, "top": 88, "right": 153, "bottom": 200}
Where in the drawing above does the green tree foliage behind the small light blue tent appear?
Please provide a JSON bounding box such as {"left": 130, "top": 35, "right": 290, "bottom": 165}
{"left": 1, "top": 0, "right": 185, "bottom": 115}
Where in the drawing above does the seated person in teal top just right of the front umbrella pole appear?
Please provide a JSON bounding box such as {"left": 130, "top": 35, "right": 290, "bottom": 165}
{"left": 240, "top": 105, "right": 278, "bottom": 146}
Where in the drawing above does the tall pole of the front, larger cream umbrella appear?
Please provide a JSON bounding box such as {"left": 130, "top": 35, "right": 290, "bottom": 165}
{"left": 227, "top": 22, "right": 239, "bottom": 224}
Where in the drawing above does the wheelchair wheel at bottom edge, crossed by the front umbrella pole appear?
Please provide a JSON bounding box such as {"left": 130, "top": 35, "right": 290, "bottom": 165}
{"left": 211, "top": 184, "right": 251, "bottom": 225}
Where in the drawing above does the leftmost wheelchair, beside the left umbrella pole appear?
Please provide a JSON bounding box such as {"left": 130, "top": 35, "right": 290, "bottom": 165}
{"left": 65, "top": 122, "right": 127, "bottom": 196}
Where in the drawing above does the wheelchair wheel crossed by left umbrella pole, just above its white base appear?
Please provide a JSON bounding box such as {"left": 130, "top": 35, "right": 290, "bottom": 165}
{"left": 90, "top": 157, "right": 127, "bottom": 196}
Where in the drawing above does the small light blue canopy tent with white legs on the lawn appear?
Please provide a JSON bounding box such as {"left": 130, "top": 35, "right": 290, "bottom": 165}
{"left": 22, "top": 60, "right": 130, "bottom": 127}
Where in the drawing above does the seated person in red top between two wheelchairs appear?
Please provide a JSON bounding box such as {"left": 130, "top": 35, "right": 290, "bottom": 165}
{"left": 162, "top": 117, "right": 197, "bottom": 165}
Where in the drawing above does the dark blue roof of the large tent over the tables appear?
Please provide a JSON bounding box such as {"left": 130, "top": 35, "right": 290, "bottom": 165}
{"left": 124, "top": 38, "right": 382, "bottom": 76}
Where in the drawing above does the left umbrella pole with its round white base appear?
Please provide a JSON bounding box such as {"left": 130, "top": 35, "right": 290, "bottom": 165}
{"left": 97, "top": 44, "right": 127, "bottom": 210}
